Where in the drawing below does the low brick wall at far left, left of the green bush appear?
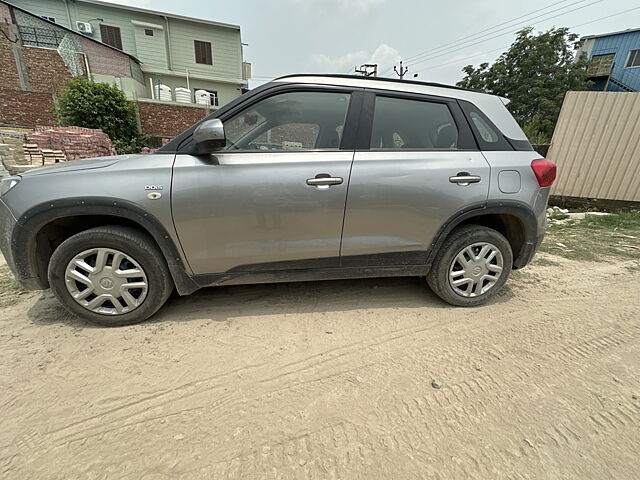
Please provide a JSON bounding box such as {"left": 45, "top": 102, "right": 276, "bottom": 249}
{"left": 0, "top": 90, "right": 55, "bottom": 126}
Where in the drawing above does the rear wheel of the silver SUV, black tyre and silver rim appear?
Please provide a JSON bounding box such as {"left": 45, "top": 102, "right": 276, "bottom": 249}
{"left": 427, "top": 225, "right": 513, "bottom": 307}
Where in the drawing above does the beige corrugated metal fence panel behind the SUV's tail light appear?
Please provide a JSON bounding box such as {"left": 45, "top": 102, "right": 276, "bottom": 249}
{"left": 548, "top": 92, "right": 640, "bottom": 202}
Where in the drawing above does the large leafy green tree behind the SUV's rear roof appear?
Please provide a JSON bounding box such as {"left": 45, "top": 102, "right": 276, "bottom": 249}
{"left": 458, "top": 28, "right": 589, "bottom": 143}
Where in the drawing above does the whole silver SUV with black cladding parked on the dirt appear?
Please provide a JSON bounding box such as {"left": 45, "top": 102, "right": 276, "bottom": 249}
{"left": 0, "top": 75, "right": 555, "bottom": 325}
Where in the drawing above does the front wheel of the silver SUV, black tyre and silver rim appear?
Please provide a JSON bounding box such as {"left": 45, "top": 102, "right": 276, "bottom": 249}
{"left": 49, "top": 226, "right": 174, "bottom": 326}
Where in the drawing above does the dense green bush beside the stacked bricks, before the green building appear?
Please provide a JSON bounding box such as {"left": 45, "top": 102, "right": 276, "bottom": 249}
{"left": 56, "top": 78, "right": 148, "bottom": 154}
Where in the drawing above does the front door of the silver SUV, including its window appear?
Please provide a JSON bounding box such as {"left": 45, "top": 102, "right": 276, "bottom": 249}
{"left": 172, "top": 90, "right": 353, "bottom": 274}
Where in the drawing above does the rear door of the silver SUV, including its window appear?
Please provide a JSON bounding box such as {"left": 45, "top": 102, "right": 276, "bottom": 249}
{"left": 341, "top": 92, "right": 490, "bottom": 266}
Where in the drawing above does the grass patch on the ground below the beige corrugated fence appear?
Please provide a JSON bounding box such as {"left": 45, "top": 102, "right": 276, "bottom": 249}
{"left": 540, "top": 210, "right": 640, "bottom": 262}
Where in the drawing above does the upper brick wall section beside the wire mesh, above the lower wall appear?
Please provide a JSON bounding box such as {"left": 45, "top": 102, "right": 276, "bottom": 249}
{"left": 22, "top": 47, "right": 86, "bottom": 93}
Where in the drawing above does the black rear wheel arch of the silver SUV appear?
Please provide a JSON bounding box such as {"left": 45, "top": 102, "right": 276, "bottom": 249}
{"left": 427, "top": 201, "right": 539, "bottom": 269}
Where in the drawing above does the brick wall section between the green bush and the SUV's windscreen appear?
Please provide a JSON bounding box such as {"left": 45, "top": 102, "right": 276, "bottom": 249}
{"left": 138, "top": 102, "right": 212, "bottom": 137}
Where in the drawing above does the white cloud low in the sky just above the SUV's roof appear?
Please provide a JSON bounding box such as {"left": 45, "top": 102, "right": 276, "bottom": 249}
{"left": 307, "top": 43, "right": 400, "bottom": 73}
